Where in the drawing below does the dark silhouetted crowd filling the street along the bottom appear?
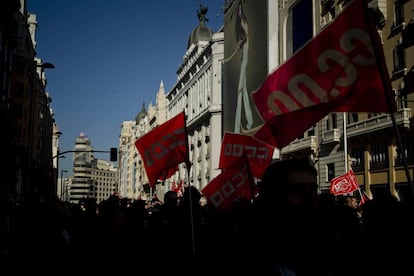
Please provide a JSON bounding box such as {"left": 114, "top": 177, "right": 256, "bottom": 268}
{"left": 1, "top": 157, "right": 414, "bottom": 276}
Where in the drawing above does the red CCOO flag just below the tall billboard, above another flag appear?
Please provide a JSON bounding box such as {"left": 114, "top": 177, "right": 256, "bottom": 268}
{"left": 218, "top": 132, "right": 274, "bottom": 178}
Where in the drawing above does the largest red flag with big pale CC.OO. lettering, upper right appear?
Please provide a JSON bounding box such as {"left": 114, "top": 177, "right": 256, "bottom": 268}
{"left": 252, "top": 0, "right": 396, "bottom": 148}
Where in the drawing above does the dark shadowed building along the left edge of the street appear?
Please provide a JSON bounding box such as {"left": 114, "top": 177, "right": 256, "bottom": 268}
{"left": 0, "top": 0, "right": 57, "bottom": 206}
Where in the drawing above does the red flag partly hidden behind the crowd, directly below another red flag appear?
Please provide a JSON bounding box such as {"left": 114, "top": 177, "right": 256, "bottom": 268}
{"left": 201, "top": 158, "right": 252, "bottom": 210}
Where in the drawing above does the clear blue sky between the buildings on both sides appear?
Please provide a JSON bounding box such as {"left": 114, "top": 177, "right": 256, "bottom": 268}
{"left": 27, "top": 0, "right": 224, "bottom": 177}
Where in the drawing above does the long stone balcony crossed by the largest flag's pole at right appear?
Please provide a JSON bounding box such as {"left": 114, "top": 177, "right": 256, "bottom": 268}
{"left": 346, "top": 108, "right": 411, "bottom": 137}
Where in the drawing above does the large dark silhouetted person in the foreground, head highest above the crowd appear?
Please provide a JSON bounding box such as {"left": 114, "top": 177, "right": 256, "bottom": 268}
{"left": 251, "top": 158, "right": 332, "bottom": 276}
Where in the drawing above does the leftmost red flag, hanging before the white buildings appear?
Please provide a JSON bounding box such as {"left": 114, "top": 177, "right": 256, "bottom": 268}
{"left": 135, "top": 112, "right": 190, "bottom": 187}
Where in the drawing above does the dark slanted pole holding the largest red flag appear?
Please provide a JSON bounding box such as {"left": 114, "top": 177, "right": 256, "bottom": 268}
{"left": 362, "top": 0, "right": 414, "bottom": 201}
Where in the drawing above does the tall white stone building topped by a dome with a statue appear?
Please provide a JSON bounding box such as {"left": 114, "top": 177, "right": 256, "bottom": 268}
{"left": 165, "top": 5, "right": 224, "bottom": 192}
